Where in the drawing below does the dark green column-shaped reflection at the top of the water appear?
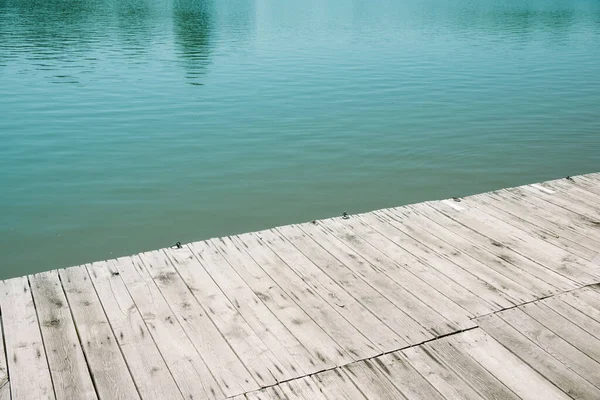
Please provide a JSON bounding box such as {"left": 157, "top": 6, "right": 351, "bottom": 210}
{"left": 173, "top": 0, "right": 214, "bottom": 85}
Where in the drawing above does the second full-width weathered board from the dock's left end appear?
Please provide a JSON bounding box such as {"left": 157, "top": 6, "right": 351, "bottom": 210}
{"left": 29, "top": 271, "right": 97, "bottom": 399}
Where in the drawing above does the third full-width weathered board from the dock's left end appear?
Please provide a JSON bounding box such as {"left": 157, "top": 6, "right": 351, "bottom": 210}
{"left": 58, "top": 267, "right": 139, "bottom": 400}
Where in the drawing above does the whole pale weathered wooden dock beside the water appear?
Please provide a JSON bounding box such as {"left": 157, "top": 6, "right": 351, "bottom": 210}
{"left": 0, "top": 174, "right": 600, "bottom": 400}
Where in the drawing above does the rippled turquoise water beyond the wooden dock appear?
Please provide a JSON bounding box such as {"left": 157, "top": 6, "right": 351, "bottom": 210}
{"left": 0, "top": 0, "right": 600, "bottom": 278}
